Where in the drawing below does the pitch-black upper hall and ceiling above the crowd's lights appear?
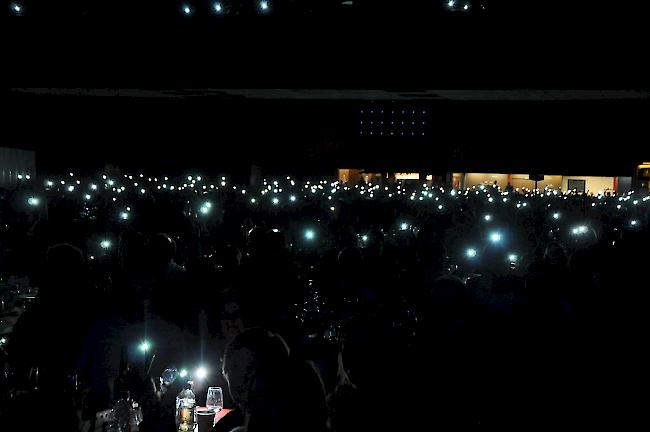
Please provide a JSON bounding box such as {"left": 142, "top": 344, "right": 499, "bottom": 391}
{"left": 2, "top": 1, "right": 650, "bottom": 174}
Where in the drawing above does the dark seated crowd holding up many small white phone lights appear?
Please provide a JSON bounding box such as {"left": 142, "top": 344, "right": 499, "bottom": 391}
{"left": 0, "top": 173, "right": 650, "bottom": 432}
